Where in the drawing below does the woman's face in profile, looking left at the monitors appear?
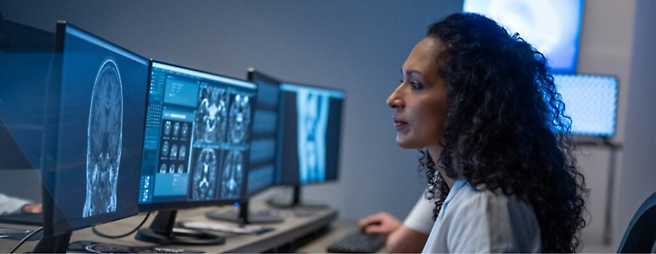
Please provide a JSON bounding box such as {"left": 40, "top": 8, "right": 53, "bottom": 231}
{"left": 387, "top": 37, "right": 448, "bottom": 149}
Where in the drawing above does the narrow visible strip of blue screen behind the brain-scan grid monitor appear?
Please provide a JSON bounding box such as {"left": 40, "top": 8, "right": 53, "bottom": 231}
{"left": 247, "top": 69, "right": 280, "bottom": 197}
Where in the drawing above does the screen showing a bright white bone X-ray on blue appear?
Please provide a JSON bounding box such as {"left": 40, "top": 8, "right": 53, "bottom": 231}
{"left": 275, "top": 83, "right": 344, "bottom": 185}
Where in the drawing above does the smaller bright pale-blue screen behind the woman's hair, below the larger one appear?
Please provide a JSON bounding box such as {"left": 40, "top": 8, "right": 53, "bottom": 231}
{"left": 553, "top": 74, "right": 618, "bottom": 137}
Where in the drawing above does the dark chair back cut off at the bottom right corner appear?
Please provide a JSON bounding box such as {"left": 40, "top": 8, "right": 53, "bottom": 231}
{"left": 617, "top": 193, "right": 656, "bottom": 253}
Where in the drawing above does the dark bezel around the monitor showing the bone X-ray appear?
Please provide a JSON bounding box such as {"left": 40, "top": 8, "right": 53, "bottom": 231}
{"left": 274, "top": 81, "right": 347, "bottom": 186}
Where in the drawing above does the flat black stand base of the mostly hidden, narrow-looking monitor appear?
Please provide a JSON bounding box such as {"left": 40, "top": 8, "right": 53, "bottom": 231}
{"left": 206, "top": 200, "right": 284, "bottom": 225}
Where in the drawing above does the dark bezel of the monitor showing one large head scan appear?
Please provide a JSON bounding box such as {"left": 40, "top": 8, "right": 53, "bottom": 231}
{"left": 42, "top": 21, "right": 148, "bottom": 236}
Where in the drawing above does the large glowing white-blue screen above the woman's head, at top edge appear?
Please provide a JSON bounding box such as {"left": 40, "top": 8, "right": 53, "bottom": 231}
{"left": 464, "top": 0, "right": 583, "bottom": 73}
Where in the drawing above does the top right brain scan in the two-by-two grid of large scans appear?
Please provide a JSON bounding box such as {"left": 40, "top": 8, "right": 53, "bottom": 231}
{"left": 230, "top": 94, "right": 251, "bottom": 144}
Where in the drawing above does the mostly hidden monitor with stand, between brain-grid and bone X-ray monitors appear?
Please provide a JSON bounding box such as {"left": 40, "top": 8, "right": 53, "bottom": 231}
{"left": 207, "top": 68, "right": 283, "bottom": 224}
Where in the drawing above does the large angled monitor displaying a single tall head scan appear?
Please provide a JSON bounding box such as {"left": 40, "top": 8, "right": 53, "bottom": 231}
{"left": 35, "top": 22, "right": 148, "bottom": 252}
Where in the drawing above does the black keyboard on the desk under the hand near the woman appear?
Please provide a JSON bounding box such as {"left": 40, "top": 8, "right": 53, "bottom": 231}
{"left": 326, "top": 231, "right": 387, "bottom": 253}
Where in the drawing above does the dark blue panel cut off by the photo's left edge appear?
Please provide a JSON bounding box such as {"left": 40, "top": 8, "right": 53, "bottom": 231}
{"left": 0, "top": 15, "right": 55, "bottom": 169}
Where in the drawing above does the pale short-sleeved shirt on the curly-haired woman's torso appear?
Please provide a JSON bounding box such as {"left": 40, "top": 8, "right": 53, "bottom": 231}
{"left": 423, "top": 180, "right": 542, "bottom": 253}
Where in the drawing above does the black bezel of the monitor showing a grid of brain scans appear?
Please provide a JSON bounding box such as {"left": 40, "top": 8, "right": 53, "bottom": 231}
{"left": 137, "top": 59, "right": 258, "bottom": 212}
